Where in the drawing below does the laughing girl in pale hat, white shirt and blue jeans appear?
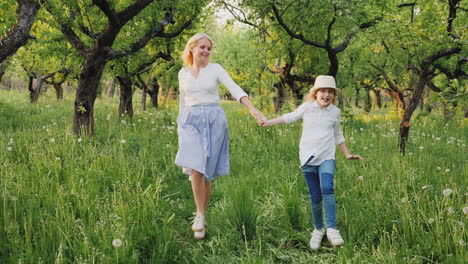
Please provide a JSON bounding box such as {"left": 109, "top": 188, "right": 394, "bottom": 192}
{"left": 262, "top": 75, "right": 363, "bottom": 250}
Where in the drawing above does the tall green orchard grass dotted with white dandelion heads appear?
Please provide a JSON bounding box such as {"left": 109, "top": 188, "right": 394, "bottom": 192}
{"left": 0, "top": 91, "right": 468, "bottom": 264}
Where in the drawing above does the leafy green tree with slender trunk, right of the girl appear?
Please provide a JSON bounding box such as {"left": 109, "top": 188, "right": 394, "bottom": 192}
{"left": 369, "top": 0, "right": 462, "bottom": 154}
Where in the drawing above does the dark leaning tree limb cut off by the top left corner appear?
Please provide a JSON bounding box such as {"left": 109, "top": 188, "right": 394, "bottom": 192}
{"left": 0, "top": 0, "right": 40, "bottom": 63}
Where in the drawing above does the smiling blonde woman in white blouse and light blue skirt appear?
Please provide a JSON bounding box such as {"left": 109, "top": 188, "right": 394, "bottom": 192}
{"left": 175, "top": 33, "right": 266, "bottom": 239}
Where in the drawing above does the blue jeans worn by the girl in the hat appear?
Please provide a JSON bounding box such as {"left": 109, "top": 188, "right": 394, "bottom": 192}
{"left": 301, "top": 160, "right": 336, "bottom": 229}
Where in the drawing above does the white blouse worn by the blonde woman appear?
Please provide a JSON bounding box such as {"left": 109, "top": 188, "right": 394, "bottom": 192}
{"left": 179, "top": 63, "right": 247, "bottom": 109}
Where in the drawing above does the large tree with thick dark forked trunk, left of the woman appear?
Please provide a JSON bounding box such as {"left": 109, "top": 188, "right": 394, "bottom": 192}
{"left": 46, "top": 0, "right": 204, "bottom": 136}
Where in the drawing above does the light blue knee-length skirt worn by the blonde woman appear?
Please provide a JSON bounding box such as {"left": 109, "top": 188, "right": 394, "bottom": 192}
{"left": 175, "top": 104, "right": 229, "bottom": 181}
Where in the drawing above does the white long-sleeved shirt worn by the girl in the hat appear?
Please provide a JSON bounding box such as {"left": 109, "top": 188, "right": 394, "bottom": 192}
{"left": 283, "top": 101, "right": 345, "bottom": 166}
